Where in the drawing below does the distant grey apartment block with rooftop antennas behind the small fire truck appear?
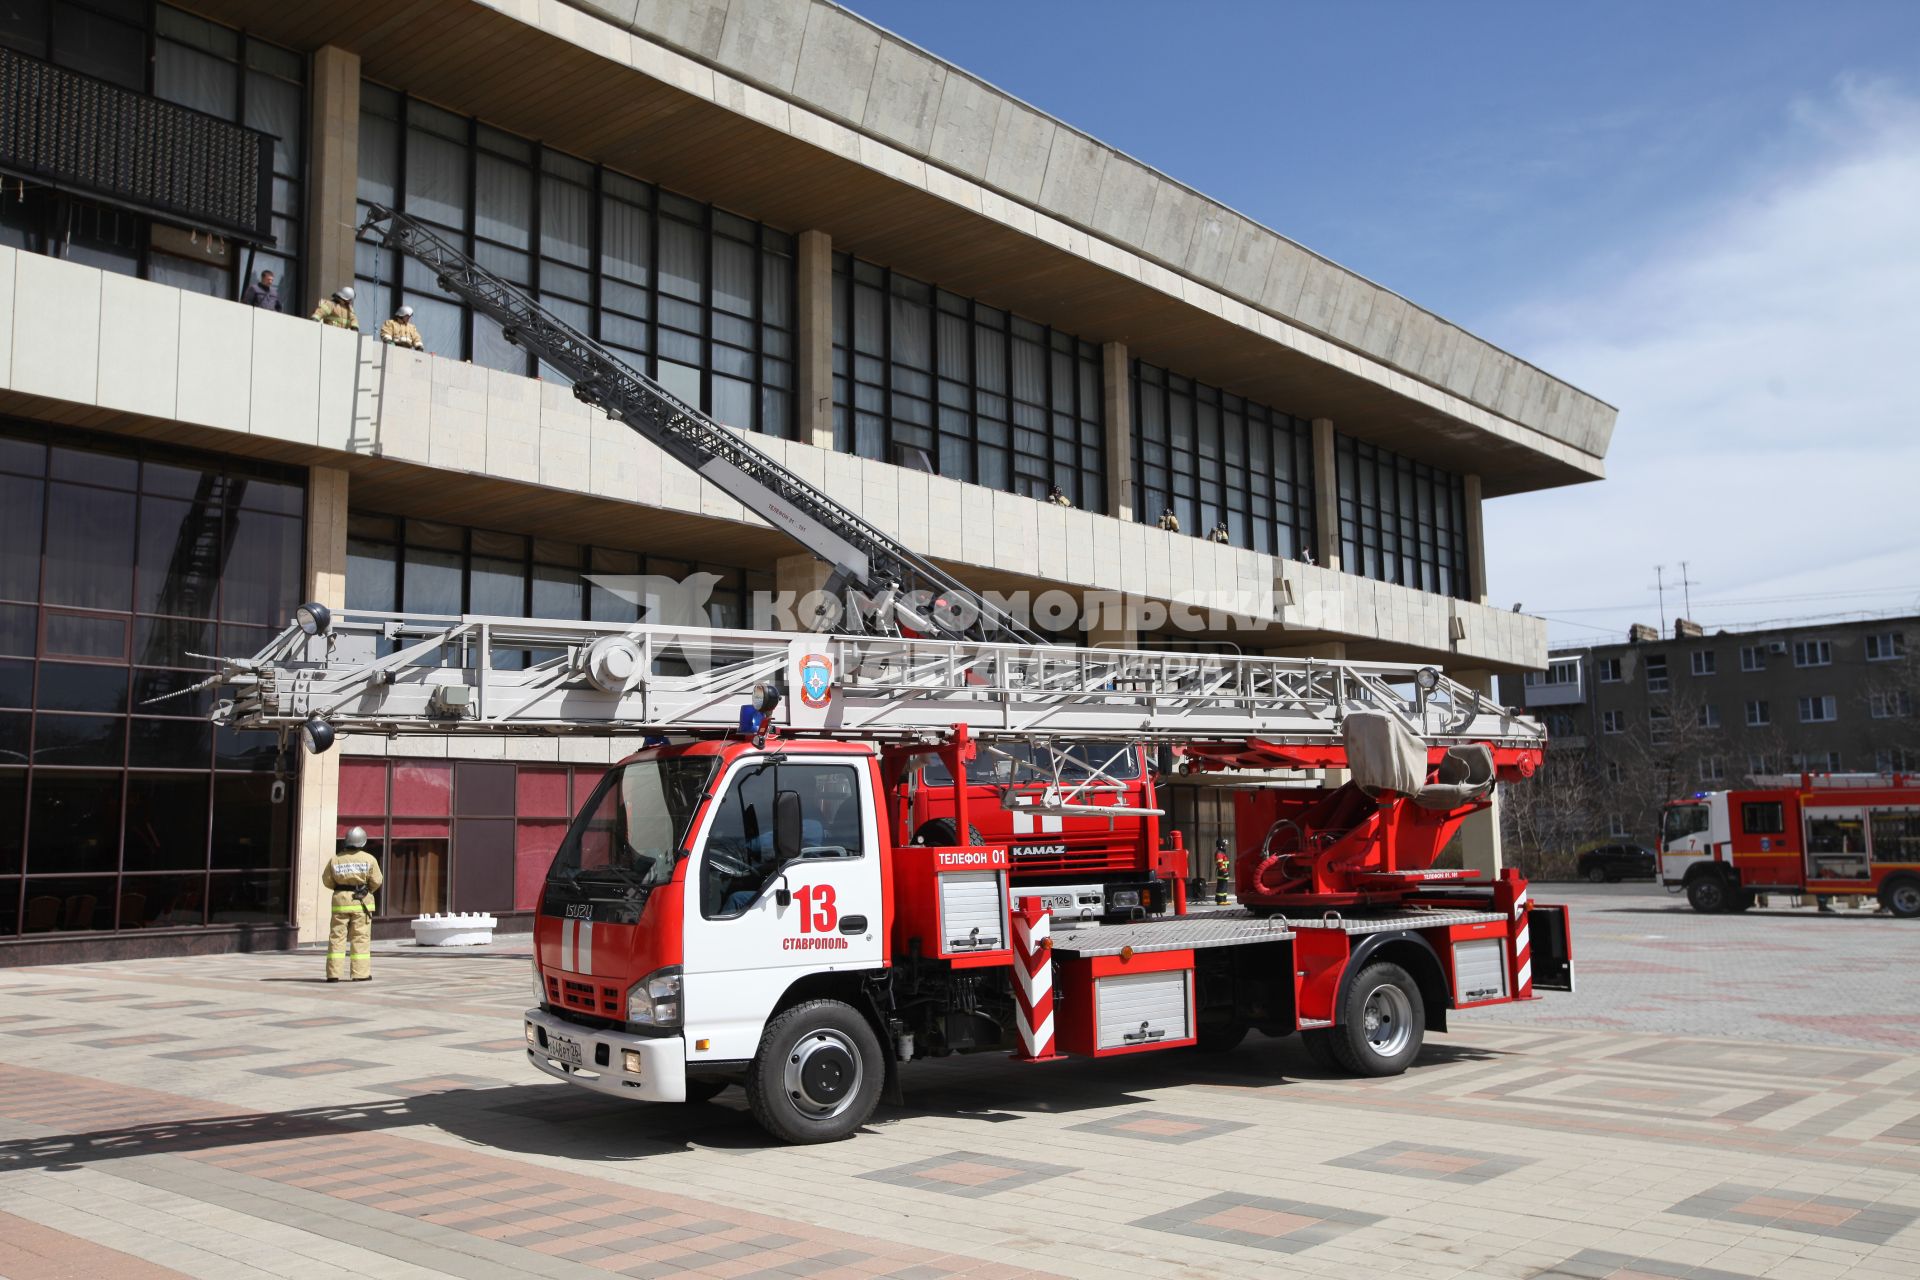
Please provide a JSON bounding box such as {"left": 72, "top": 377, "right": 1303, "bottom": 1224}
{"left": 1501, "top": 618, "right": 1920, "bottom": 846}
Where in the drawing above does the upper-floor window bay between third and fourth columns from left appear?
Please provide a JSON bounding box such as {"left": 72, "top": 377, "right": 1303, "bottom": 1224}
{"left": 1133, "top": 361, "right": 1313, "bottom": 558}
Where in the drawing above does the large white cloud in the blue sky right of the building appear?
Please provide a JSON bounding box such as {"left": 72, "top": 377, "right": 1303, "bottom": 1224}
{"left": 1486, "top": 81, "right": 1920, "bottom": 643}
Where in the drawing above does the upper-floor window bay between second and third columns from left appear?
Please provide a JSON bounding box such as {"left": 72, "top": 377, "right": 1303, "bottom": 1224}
{"left": 833, "top": 253, "right": 1106, "bottom": 510}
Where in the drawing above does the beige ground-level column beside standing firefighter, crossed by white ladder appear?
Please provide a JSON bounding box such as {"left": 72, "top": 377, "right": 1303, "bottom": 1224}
{"left": 292, "top": 466, "right": 348, "bottom": 942}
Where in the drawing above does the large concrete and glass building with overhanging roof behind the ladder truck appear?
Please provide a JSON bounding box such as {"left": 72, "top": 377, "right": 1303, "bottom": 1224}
{"left": 0, "top": 0, "right": 1615, "bottom": 956}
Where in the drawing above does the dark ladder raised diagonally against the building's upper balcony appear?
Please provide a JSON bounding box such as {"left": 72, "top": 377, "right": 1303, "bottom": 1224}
{"left": 361, "top": 205, "right": 1046, "bottom": 645}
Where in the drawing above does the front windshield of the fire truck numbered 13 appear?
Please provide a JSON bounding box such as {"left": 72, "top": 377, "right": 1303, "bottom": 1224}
{"left": 547, "top": 756, "right": 714, "bottom": 887}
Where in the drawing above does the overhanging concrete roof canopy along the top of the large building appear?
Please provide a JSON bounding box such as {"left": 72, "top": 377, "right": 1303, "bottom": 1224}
{"left": 186, "top": 0, "right": 1615, "bottom": 497}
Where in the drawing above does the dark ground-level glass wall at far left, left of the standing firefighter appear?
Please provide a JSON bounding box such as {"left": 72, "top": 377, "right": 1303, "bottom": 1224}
{"left": 0, "top": 422, "right": 305, "bottom": 935}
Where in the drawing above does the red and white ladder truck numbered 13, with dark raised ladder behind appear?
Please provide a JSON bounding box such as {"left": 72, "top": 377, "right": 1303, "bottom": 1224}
{"left": 194, "top": 209, "right": 1572, "bottom": 1142}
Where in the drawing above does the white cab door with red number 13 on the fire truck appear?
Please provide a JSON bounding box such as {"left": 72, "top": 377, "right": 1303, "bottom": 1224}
{"left": 682, "top": 752, "right": 885, "bottom": 1061}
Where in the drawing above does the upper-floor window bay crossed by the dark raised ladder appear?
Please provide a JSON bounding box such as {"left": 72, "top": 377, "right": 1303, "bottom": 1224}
{"left": 357, "top": 83, "right": 793, "bottom": 438}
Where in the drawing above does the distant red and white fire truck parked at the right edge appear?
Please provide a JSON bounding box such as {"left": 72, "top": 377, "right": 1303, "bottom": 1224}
{"left": 1661, "top": 773, "right": 1920, "bottom": 917}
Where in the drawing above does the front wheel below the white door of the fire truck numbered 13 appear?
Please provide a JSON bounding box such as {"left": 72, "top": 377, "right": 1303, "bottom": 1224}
{"left": 747, "top": 1000, "right": 887, "bottom": 1144}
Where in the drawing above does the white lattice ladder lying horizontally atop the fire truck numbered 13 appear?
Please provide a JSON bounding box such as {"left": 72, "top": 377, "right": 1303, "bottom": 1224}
{"left": 207, "top": 610, "right": 1546, "bottom": 747}
